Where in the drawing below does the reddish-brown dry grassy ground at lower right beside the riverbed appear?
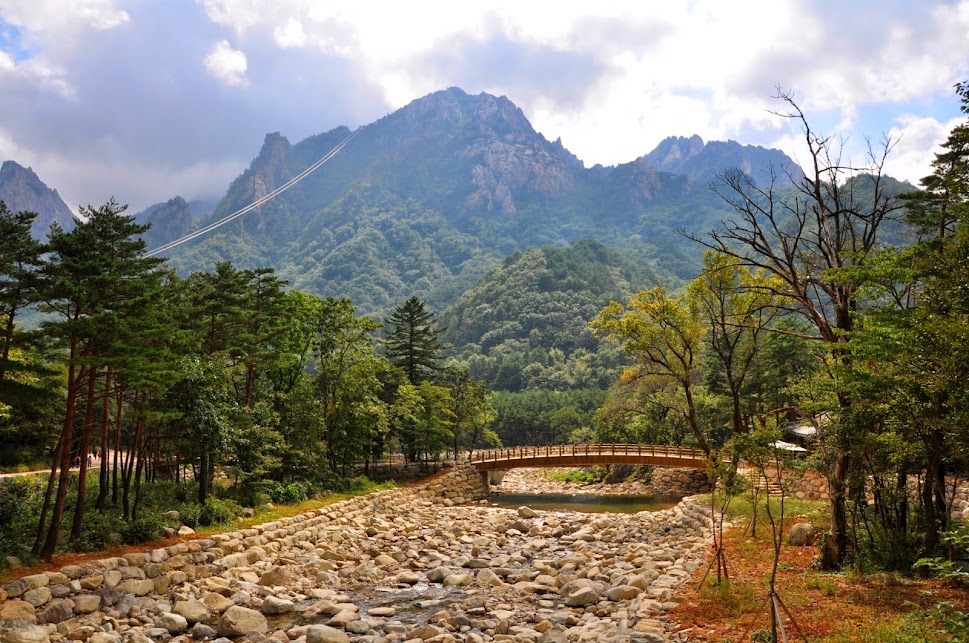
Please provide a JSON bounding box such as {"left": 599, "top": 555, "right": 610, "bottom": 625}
{"left": 670, "top": 508, "right": 969, "bottom": 643}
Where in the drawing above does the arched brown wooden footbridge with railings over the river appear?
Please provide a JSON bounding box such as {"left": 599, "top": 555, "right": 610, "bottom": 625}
{"left": 470, "top": 444, "right": 709, "bottom": 471}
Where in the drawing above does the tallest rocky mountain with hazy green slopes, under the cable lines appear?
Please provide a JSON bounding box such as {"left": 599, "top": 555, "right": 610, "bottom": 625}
{"left": 159, "top": 88, "right": 804, "bottom": 312}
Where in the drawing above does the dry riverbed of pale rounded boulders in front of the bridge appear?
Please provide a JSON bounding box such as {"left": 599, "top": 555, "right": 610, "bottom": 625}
{"left": 0, "top": 468, "right": 710, "bottom": 643}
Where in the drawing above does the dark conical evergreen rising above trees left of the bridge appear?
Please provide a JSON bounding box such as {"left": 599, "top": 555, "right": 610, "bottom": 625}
{"left": 383, "top": 297, "right": 444, "bottom": 385}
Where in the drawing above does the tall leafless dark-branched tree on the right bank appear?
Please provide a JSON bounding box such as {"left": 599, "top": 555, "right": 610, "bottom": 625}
{"left": 694, "top": 88, "right": 900, "bottom": 565}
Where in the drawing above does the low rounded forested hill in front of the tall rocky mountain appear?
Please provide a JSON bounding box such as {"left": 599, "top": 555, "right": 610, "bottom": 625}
{"left": 440, "top": 239, "right": 657, "bottom": 391}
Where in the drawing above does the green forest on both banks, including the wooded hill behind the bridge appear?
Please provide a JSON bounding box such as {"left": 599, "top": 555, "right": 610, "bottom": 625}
{"left": 0, "top": 85, "right": 969, "bottom": 588}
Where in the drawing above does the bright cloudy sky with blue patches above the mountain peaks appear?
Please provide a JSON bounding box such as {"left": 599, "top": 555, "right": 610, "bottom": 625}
{"left": 0, "top": 0, "right": 969, "bottom": 211}
